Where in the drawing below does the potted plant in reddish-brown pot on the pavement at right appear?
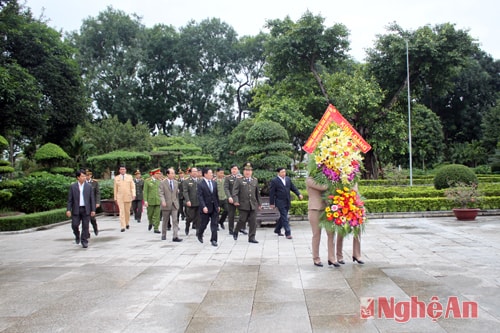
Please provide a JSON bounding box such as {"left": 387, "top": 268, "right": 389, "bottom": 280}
{"left": 444, "top": 182, "right": 480, "bottom": 221}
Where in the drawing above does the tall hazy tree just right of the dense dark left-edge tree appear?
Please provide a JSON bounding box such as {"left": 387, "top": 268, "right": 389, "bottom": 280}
{"left": 71, "top": 7, "right": 144, "bottom": 124}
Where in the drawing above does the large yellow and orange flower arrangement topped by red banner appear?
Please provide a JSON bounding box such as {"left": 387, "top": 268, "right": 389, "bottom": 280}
{"left": 304, "top": 105, "right": 371, "bottom": 237}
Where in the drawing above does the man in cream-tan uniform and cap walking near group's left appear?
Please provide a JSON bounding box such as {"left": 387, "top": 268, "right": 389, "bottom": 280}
{"left": 114, "top": 165, "right": 135, "bottom": 232}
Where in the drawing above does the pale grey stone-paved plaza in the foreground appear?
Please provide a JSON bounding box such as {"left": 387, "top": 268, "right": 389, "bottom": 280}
{"left": 0, "top": 211, "right": 500, "bottom": 333}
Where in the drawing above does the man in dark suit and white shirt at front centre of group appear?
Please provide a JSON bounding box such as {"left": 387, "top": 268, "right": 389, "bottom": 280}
{"left": 196, "top": 168, "right": 220, "bottom": 246}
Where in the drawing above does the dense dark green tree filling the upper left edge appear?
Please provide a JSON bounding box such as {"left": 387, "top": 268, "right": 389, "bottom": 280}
{"left": 0, "top": 1, "right": 87, "bottom": 156}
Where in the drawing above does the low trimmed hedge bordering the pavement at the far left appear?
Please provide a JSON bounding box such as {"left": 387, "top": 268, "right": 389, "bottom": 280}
{"left": 0, "top": 208, "right": 68, "bottom": 231}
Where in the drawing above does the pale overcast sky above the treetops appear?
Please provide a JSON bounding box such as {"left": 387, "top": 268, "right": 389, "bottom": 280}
{"left": 24, "top": 0, "right": 500, "bottom": 61}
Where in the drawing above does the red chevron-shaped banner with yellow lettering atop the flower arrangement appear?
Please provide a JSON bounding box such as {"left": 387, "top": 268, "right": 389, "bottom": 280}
{"left": 302, "top": 104, "right": 372, "bottom": 154}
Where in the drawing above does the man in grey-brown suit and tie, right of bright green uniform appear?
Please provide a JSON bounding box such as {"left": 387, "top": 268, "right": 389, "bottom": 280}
{"left": 158, "top": 168, "right": 182, "bottom": 242}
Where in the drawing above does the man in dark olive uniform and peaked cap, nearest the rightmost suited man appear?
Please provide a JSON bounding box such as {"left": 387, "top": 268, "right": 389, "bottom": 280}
{"left": 232, "top": 162, "right": 262, "bottom": 243}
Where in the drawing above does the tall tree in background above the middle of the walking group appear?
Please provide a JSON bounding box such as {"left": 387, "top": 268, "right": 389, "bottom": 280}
{"left": 177, "top": 18, "right": 238, "bottom": 134}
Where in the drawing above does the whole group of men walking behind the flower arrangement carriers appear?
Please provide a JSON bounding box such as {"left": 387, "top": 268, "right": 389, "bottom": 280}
{"left": 66, "top": 162, "right": 302, "bottom": 248}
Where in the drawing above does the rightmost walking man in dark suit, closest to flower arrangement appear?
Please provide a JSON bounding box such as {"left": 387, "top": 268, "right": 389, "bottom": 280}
{"left": 269, "top": 168, "right": 303, "bottom": 239}
